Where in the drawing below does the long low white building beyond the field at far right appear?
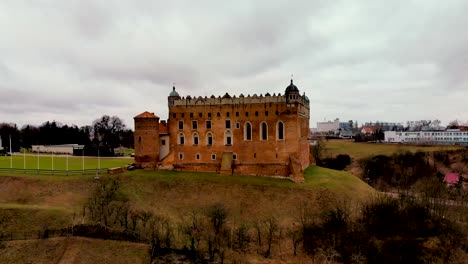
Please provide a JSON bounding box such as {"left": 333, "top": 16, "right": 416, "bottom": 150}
{"left": 384, "top": 129, "right": 468, "bottom": 146}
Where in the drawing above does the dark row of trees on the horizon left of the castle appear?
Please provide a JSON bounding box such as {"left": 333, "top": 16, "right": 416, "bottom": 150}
{"left": 0, "top": 115, "right": 134, "bottom": 152}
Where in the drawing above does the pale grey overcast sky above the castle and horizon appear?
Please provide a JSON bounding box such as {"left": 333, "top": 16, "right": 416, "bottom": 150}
{"left": 0, "top": 0, "right": 468, "bottom": 128}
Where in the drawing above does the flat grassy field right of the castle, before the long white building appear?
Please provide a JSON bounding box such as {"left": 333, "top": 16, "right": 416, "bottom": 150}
{"left": 325, "top": 140, "right": 463, "bottom": 159}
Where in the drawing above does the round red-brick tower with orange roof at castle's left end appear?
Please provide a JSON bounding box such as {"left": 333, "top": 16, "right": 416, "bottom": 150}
{"left": 133, "top": 112, "right": 160, "bottom": 168}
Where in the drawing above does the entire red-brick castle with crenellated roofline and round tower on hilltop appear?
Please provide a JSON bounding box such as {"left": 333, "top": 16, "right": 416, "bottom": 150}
{"left": 134, "top": 80, "right": 310, "bottom": 181}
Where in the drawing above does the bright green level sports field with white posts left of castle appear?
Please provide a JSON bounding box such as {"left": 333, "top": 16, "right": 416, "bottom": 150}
{"left": 0, "top": 155, "right": 133, "bottom": 170}
